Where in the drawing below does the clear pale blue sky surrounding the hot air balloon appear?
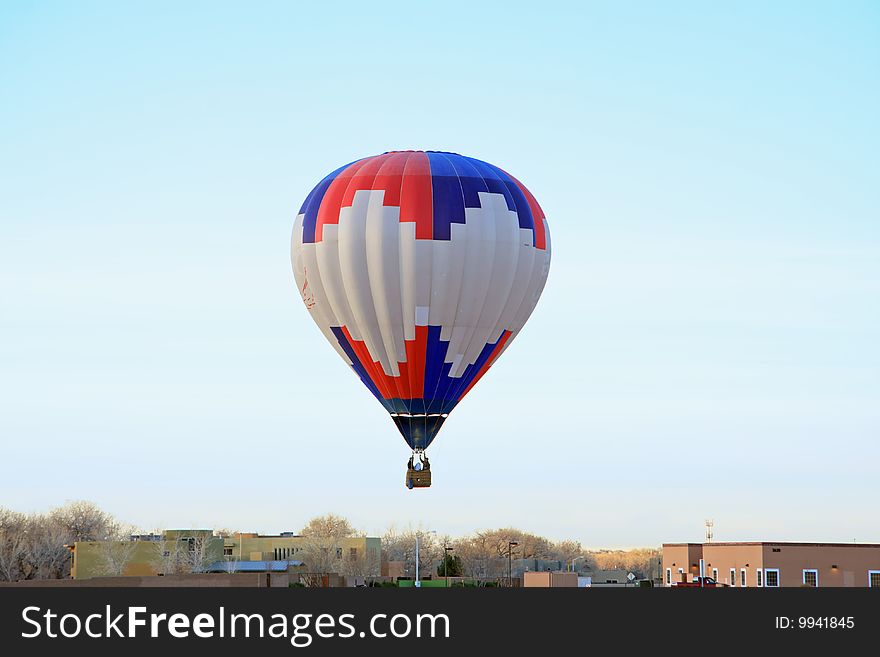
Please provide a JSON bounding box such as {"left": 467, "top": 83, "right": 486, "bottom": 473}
{"left": 0, "top": 1, "right": 880, "bottom": 547}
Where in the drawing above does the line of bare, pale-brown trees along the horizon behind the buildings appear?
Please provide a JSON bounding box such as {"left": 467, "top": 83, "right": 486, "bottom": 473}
{"left": 0, "top": 501, "right": 660, "bottom": 581}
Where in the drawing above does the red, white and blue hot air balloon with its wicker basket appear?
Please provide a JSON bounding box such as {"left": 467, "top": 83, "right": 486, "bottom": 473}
{"left": 291, "top": 151, "right": 550, "bottom": 488}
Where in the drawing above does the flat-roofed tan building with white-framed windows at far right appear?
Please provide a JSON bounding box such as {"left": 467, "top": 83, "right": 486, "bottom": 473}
{"left": 663, "top": 542, "right": 880, "bottom": 588}
